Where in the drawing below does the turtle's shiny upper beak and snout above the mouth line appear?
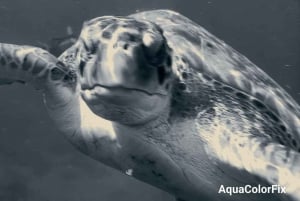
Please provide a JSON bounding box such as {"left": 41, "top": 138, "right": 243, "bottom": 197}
{"left": 80, "top": 28, "right": 168, "bottom": 95}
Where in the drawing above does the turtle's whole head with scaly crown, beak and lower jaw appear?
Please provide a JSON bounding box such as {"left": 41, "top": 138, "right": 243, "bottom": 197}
{"left": 79, "top": 17, "right": 172, "bottom": 124}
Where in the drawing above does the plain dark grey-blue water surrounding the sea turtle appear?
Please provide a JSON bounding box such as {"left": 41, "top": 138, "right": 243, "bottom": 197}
{"left": 0, "top": 0, "right": 300, "bottom": 201}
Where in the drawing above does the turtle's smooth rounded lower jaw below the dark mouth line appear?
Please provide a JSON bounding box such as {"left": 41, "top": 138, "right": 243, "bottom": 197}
{"left": 81, "top": 86, "right": 169, "bottom": 125}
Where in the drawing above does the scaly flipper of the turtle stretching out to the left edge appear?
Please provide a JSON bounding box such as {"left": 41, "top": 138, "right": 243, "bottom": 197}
{"left": 0, "top": 43, "right": 72, "bottom": 89}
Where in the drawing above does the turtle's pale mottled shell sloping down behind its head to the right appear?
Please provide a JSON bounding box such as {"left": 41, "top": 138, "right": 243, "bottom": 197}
{"left": 131, "top": 10, "right": 300, "bottom": 144}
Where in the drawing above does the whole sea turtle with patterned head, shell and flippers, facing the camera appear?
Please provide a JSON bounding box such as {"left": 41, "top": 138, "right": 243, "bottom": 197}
{"left": 0, "top": 10, "right": 300, "bottom": 201}
